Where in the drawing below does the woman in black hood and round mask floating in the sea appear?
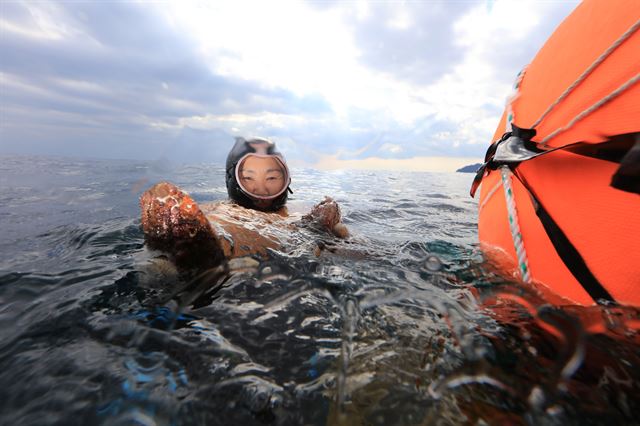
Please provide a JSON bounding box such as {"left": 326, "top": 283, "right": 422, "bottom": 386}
{"left": 140, "top": 138, "right": 348, "bottom": 268}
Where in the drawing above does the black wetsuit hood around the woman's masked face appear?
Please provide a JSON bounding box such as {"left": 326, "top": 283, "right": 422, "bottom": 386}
{"left": 225, "top": 137, "right": 291, "bottom": 211}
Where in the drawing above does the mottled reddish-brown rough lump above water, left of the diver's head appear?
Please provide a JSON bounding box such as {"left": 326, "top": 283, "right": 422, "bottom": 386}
{"left": 140, "top": 182, "right": 224, "bottom": 268}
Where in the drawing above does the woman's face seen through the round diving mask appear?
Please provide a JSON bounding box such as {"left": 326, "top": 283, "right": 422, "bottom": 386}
{"left": 239, "top": 155, "right": 285, "bottom": 208}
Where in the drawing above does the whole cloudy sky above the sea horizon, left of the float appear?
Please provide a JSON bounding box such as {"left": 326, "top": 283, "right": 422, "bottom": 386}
{"left": 0, "top": 0, "right": 577, "bottom": 171}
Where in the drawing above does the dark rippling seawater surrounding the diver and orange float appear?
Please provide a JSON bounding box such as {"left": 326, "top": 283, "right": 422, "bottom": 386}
{"left": 0, "top": 157, "right": 640, "bottom": 425}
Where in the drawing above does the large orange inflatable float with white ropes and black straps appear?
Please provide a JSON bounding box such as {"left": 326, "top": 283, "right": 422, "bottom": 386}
{"left": 471, "top": 0, "right": 640, "bottom": 306}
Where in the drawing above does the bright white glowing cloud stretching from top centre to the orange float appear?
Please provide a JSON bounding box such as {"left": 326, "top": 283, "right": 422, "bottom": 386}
{"left": 156, "top": 1, "right": 580, "bottom": 152}
